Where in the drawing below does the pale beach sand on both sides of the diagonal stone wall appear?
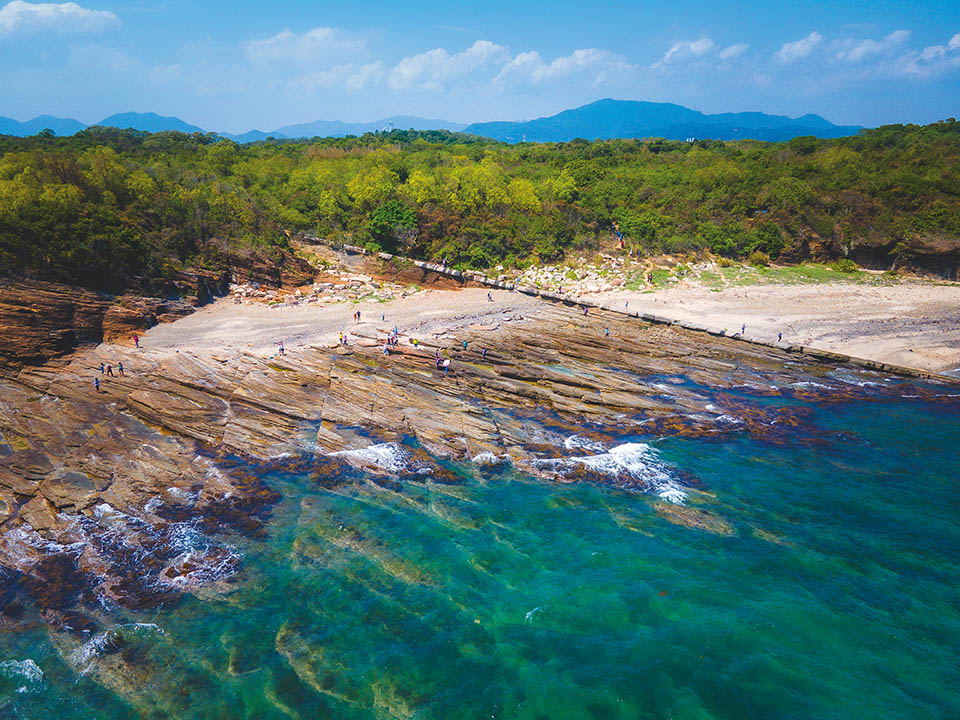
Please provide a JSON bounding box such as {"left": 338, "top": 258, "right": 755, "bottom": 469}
{"left": 143, "top": 282, "right": 960, "bottom": 372}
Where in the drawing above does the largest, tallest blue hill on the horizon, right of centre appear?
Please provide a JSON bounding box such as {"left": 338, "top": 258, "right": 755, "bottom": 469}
{"left": 464, "top": 99, "right": 862, "bottom": 143}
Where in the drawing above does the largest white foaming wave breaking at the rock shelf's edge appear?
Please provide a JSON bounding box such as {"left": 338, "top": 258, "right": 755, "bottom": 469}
{"left": 532, "top": 443, "right": 687, "bottom": 505}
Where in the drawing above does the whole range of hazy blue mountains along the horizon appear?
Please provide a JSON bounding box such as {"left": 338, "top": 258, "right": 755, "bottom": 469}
{"left": 0, "top": 99, "right": 862, "bottom": 143}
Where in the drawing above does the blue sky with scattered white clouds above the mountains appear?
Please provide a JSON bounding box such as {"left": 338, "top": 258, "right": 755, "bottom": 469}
{"left": 0, "top": 0, "right": 960, "bottom": 132}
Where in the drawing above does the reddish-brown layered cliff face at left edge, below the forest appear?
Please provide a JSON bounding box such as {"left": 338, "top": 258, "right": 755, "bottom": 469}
{"left": 0, "top": 279, "right": 194, "bottom": 372}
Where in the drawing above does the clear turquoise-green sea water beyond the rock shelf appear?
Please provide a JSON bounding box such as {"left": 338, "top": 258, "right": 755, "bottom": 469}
{"left": 0, "top": 390, "right": 960, "bottom": 720}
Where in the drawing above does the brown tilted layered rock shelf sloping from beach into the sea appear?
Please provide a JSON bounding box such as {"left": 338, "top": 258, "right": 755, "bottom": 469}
{"left": 0, "top": 302, "right": 957, "bottom": 714}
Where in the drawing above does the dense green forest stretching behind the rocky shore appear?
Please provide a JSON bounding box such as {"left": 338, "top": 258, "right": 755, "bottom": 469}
{"left": 0, "top": 121, "right": 960, "bottom": 290}
